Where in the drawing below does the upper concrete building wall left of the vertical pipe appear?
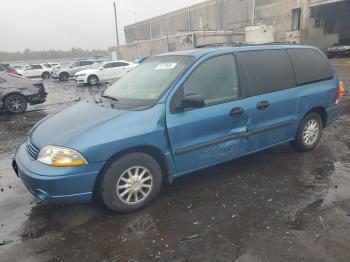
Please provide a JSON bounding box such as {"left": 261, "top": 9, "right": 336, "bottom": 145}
{"left": 124, "top": 0, "right": 252, "bottom": 44}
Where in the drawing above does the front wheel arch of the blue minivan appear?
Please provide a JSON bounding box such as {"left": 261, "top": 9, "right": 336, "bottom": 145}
{"left": 93, "top": 145, "right": 174, "bottom": 199}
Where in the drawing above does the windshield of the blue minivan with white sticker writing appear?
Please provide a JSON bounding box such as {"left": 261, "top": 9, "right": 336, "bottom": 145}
{"left": 103, "top": 55, "right": 194, "bottom": 106}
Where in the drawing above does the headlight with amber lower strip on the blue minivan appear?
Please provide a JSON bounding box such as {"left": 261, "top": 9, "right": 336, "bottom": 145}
{"left": 38, "top": 146, "right": 88, "bottom": 167}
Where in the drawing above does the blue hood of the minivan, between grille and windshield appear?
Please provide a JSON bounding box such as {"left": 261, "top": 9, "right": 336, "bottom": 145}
{"left": 30, "top": 102, "right": 126, "bottom": 148}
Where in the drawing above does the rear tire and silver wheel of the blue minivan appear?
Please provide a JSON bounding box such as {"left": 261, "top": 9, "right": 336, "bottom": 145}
{"left": 291, "top": 112, "right": 323, "bottom": 152}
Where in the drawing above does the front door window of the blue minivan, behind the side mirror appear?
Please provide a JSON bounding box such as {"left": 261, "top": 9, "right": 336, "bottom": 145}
{"left": 183, "top": 54, "right": 239, "bottom": 105}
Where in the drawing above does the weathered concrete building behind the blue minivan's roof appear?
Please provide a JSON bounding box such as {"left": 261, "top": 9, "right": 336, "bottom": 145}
{"left": 110, "top": 0, "right": 350, "bottom": 60}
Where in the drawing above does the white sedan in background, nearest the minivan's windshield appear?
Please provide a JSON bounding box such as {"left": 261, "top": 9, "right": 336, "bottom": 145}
{"left": 75, "top": 60, "right": 138, "bottom": 85}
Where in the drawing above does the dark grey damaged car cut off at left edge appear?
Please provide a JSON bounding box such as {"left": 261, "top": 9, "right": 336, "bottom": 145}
{"left": 0, "top": 72, "right": 47, "bottom": 114}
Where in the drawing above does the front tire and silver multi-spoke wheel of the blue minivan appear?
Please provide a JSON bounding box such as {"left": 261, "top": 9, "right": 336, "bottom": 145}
{"left": 99, "top": 153, "right": 162, "bottom": 213}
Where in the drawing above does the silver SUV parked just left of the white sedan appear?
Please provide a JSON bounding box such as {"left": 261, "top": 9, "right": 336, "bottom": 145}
{"left": 51, "top": 60, "right": 99, "bottom": 81}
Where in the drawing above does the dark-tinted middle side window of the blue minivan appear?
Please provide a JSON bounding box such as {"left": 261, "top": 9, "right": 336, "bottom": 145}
{"left": 239, "top": 50, "right": 296, "bottom": 96}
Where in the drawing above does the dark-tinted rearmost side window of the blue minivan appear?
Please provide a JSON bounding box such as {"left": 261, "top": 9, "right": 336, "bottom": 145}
{"left": 288, "top": 48, "right": 334, "bottom": 85}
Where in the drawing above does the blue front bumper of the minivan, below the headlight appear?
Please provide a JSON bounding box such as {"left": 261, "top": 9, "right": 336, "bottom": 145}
{"left": 12, "top": 143, "right": 104, "bottom": 204}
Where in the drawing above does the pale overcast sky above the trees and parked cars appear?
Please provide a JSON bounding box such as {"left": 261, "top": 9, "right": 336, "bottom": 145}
{"left": 0, "top": 0, "right": 203, "bottom": 51}
